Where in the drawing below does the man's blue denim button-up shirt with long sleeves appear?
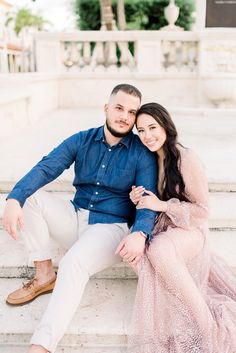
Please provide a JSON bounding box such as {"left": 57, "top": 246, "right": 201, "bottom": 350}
{"left": 7, "top": 127, "right": 157, "bottom": 239}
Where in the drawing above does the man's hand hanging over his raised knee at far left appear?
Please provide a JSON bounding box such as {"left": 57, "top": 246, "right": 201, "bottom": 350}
{"left": 3, "top": 199, "right": 24, "bottom": 239}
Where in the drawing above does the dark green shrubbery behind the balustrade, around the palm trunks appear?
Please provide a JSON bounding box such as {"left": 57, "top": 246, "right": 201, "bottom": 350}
{"left": 75, "top": 0, "right": 194, "bottom": 30}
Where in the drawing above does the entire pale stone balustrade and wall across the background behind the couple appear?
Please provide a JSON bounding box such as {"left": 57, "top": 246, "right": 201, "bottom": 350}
{"left": 0, "top": 28, "right": 236, "bottom": 121}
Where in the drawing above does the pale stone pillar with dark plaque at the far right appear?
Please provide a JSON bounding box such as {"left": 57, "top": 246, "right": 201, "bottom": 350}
{"left": 195, "top": 0, "right": 236, "bottom": 108}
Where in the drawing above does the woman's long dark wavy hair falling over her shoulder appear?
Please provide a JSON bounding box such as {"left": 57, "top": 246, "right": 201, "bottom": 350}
{"left": 136, "top": 103, "right": 189, "bottom": 201}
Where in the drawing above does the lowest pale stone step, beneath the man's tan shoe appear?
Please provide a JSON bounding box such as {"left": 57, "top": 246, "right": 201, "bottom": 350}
{"left": 0, "top": 279, "right": 136, "bottom": 353}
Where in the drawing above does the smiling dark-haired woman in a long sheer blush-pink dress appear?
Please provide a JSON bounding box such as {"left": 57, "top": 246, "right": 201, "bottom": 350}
{"left": 128, "top": 103, "right": 236, "bottom": 353}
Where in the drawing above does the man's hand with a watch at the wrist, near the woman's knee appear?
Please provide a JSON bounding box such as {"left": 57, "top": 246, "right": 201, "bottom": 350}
{"left": 115, "top": 232, "right": 146, "bottom": 265}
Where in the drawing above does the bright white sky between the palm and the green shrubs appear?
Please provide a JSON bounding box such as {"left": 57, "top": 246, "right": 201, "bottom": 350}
{"left": 7, "top": 0, "right": 75, "bottom": 31}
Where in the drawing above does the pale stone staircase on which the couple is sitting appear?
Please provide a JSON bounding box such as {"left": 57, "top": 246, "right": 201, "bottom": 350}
{"left": 0, "top": 109, "right": 236, "bottom": 353}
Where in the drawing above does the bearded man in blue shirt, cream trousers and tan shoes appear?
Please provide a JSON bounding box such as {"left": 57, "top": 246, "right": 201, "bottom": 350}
{"left": 4, "top": 84, "right": 157, "bottom": 353}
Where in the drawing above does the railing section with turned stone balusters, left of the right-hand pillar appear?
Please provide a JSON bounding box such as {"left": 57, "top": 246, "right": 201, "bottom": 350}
{"left": 35, "top": 31, "right": 198, "bottom": 73}
